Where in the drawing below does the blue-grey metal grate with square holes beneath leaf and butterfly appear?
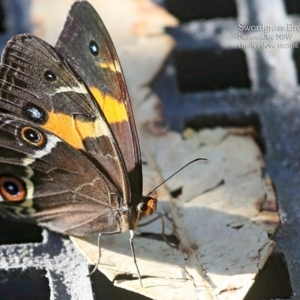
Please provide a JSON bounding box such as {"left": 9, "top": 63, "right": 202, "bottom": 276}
{"left": 0, "top": 0, "right": 300, "bottom": 300}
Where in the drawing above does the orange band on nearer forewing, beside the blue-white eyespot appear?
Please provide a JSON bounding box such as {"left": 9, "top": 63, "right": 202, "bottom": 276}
{"left": 42, "top": 112, "right": 97, "bottom": 149}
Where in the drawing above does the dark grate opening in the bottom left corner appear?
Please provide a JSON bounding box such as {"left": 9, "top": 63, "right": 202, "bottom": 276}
{"left": 0, "top": 268, "right": 50, "bottom": 300}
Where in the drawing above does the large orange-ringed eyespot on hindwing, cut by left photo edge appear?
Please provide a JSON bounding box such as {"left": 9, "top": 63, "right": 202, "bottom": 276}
{"left": 0, "top": 176, "right": 26, "bottom": 202}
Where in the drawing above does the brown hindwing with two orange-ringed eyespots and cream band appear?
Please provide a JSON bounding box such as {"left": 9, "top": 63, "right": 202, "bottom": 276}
{"left": 0, "top": 114, "right": 126, "bottom": 236}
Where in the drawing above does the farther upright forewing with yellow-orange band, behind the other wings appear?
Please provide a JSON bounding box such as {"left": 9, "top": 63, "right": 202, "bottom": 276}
{"left": 55, "top": 2, "right": 142, "bottom": 196}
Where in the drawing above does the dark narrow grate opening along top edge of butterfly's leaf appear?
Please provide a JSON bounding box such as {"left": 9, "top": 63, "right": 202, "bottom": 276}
{"left": 184, "top": 113, "right": 267, "bottom": 155}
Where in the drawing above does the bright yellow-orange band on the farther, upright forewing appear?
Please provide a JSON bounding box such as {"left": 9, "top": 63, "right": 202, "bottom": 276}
{"left": 90, "top": 86, "right": 128, "bottom": 124}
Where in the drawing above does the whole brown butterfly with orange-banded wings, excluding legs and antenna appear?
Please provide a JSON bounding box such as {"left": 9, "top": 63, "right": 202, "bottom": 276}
{"left": 0, "top": 1, "right": 156, "bottom": 236}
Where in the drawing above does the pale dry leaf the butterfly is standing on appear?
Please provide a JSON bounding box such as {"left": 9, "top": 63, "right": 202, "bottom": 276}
{"left": 73, "top": 128, "right": 279, "bottom": 300}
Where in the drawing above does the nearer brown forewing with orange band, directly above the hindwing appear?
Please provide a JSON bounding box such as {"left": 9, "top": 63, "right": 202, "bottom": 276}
{"left": 0, "top": 34, "right": 130, "bottom": 205}
